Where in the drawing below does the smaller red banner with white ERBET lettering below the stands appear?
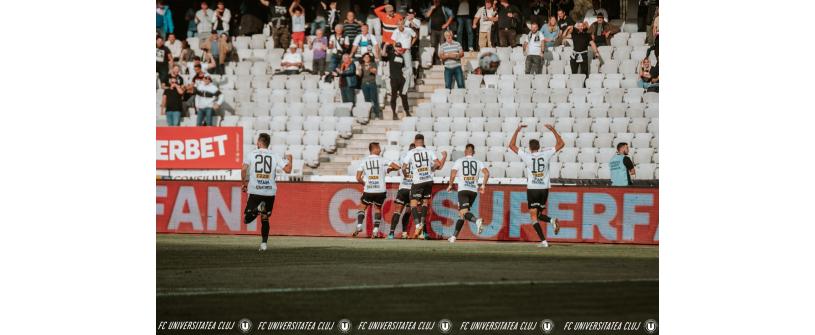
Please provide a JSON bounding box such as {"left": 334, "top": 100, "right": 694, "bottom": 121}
{"left": 156, "top": 127, "right": 243, "bottom": 169}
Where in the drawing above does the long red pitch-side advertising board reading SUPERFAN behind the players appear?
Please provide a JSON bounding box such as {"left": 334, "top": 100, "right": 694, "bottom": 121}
{"left": 156, "top": 181, "right": 659, "bottom": 244}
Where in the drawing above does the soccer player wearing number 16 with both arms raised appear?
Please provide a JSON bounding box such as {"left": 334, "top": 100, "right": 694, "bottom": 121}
{"left": 509, "top": 124, "right": 565, "bottom": 248}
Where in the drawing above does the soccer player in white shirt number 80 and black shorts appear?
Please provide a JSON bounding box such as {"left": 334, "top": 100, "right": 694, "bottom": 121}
{"left": 447, "top": 143, "right": 490, "bottom": 243}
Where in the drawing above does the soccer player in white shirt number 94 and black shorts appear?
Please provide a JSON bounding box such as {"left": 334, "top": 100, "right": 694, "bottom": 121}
{"left": 402, "top": 134, "right": 447, "bottom": 238}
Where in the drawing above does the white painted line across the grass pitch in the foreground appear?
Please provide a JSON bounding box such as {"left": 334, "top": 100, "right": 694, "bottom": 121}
{"left": 156, "top": 278, "right": 659, "bottom": 297}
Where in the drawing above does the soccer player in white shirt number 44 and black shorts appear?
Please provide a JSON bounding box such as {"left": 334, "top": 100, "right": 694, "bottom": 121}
{"left": 354, "top": 142, "right": 400, "bottom": 238}
